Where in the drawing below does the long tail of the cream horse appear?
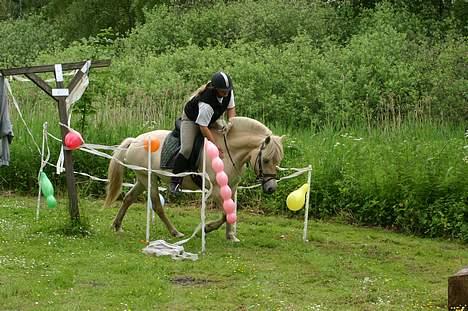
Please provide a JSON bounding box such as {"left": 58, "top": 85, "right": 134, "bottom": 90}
{"left": 104, "top": 137, "right": 135, "bottom": 207}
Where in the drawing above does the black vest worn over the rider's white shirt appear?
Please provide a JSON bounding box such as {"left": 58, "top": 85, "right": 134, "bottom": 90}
{"left": 184, "top": 89, "right": 232, "bottom": 125}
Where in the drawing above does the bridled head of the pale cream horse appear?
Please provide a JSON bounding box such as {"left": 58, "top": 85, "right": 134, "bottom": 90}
{"left": 250, "top": 135, "right": 284, "bottom": 193}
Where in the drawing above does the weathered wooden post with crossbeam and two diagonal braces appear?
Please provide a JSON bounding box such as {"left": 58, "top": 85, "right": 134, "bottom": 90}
{"left": 0, "top": 60, "right": 111, "bottom": 222}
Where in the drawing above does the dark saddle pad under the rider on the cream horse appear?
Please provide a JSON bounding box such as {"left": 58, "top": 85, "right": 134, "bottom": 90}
{"left": 160, "top": 119, "right": 203, "bottom": 171}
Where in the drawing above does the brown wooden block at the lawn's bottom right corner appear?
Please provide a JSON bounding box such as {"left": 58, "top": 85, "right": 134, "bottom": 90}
{"left": 448, "top": 267, "right": 468, "bottom": 310}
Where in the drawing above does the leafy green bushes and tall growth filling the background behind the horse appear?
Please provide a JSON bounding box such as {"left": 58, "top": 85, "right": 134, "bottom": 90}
{"left": 0, "top": 0, "right": 468, "bottom": 241}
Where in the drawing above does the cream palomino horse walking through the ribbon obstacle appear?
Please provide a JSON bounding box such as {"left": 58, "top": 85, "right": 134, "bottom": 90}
{"left": 105, "top": 117, "right": 283, "bottom": 241}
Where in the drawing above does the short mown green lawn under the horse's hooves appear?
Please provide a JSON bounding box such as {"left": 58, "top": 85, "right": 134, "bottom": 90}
{"left": 0, "top": 195, "right": 468, "bottom": 311}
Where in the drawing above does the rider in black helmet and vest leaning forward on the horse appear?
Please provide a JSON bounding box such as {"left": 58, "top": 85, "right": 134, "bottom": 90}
{"left": 169, "top": 71, "right": 236, "bottom": 194}
